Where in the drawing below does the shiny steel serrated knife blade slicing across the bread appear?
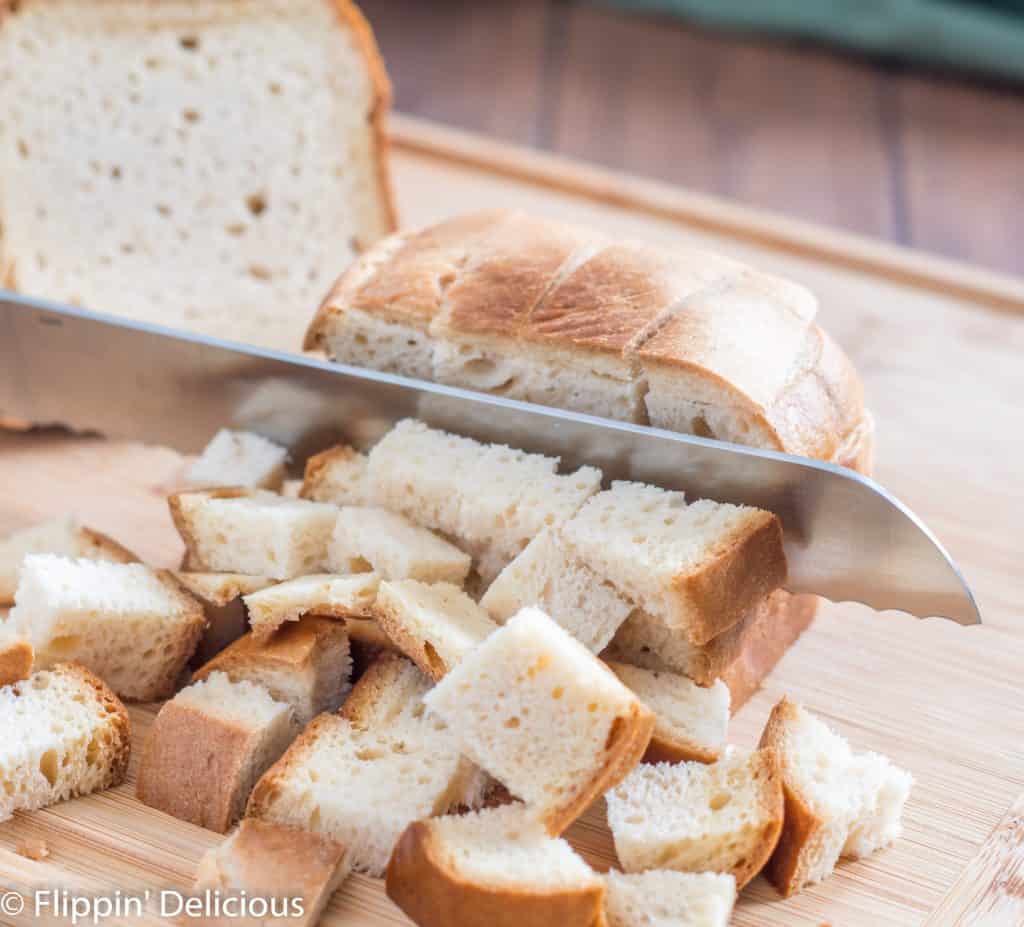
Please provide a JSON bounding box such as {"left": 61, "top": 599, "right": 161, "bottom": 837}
{"left": 0, "top": 290, "right": 981, "bottom": 624}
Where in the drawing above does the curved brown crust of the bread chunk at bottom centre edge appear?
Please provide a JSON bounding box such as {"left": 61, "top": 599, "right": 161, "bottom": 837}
{"left": 386, "top": 820, "right": 604, "bottom": 927}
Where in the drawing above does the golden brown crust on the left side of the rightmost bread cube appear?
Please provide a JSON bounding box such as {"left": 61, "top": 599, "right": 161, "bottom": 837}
{"left": 760, "top": 696, "right": 824, "bottom": 897}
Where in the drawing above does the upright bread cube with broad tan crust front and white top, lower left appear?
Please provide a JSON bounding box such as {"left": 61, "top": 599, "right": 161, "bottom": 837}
{"left": 136, "top": 673, "right": 299, "bottom": 834}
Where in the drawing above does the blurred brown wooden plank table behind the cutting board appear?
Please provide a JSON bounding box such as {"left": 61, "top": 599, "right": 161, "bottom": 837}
{"left": 360, "top": 0, "right": 1024, "bottom": 275}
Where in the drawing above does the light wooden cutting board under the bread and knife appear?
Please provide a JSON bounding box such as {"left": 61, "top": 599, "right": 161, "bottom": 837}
{"left": 0, "top": 120, "right": 1024, "bottom": 927}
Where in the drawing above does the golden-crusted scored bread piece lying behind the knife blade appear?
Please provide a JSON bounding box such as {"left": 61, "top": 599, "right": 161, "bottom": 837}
{"left": 305, "top": 210, "right": 872, "bottom": 469}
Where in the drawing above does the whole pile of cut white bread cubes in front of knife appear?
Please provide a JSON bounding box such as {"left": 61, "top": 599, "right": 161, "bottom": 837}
{"left": 0, "top": 420, "right": 911, "bottom": 927}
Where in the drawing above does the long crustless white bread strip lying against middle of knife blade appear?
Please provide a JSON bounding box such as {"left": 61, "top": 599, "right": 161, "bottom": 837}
{"left": 369, "top": 419, "right": 601, "bottom": 584}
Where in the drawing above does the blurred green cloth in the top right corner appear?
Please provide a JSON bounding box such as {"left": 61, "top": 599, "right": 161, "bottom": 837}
{"left": 610, "top": 0, "right": 1024, "bottom": 81}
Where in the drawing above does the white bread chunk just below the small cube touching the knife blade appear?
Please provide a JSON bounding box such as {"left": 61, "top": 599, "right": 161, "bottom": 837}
{"left": 167, "top": 489, "right": 338, "bottom": 580}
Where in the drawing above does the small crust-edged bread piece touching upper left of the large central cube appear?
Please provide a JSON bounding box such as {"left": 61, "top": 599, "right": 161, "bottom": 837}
{"left": 375, "top": 580, "right": 498, "bottom": 682}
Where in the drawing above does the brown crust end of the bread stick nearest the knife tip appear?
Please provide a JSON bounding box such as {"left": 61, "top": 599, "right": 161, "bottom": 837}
{"left": 673, "top": 510, "right": 787, "bottom": 645}
